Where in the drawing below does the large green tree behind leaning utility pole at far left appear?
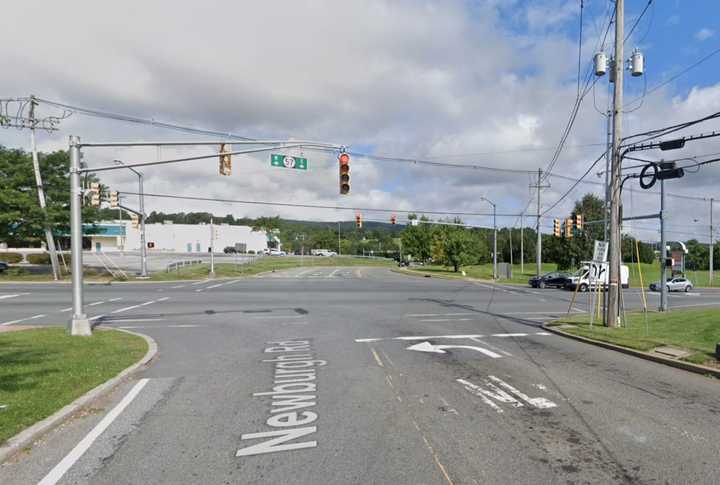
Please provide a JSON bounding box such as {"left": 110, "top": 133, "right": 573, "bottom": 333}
{"left": 0, "top": 146, "right": 99, "bottom": 246}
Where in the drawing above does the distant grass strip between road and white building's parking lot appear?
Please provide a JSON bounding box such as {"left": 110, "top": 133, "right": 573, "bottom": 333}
{"left": 150, "top": 256, "right": 397, "bottom": 281}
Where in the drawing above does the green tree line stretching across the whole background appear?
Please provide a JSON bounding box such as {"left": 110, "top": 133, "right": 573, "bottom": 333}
{"left": 0, "top": 146, "right": 720, "bottom": 270}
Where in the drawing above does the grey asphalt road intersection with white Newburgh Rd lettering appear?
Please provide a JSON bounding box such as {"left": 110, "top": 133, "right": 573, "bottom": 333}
{"left": 0, "top": 268, "right": 720, "bottom": 485}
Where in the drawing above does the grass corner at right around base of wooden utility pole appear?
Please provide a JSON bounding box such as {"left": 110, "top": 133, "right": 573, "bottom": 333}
{"left": 553, "top": 308, "right": 720, "bottom": 365}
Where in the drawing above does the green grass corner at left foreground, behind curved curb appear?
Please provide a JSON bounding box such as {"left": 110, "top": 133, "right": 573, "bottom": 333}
{"left": 0, "top": 327, "right": 147, "bottom": 444}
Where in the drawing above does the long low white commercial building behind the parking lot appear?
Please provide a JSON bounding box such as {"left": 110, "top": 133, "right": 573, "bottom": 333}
{"left": 85, "top": 221, "right": 281, "bottom": 253}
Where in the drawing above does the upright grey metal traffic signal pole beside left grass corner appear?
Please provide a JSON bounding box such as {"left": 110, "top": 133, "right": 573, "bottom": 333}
{"left": 68, "top": 136, "right": 92, "bottom": 336}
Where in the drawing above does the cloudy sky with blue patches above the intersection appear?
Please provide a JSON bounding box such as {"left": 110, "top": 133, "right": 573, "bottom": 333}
{"left": 0, "top": 0, "right": 720, "bottom": 241}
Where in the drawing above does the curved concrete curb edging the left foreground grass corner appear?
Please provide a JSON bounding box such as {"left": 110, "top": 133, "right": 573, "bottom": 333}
{"left": 0, "top": 328, "right": 158, "bottom": 464}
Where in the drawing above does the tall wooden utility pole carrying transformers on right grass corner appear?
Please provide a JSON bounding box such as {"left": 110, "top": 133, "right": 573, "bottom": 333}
{"left": 606, "top": 0, "right": 624, "bottom": 327}
